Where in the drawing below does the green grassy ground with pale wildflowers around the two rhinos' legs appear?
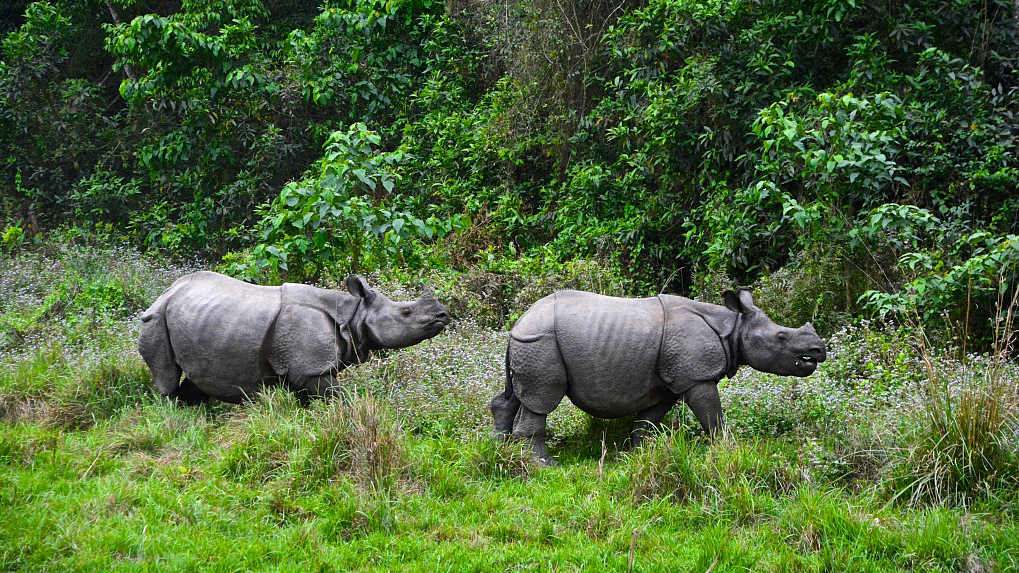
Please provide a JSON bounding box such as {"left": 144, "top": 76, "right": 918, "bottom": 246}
{"left": 0, "top": 241, "right": 1019, "bottom": 571}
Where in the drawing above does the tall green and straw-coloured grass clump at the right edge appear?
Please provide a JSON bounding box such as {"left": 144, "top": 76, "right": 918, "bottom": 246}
{"left": 888, "top": 291, "right": 1019, "bottom": 505}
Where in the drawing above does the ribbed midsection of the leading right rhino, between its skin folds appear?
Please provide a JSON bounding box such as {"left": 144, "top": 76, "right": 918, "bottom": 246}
{"left": 555, "top": 296, "right": 668, "bottom": 418}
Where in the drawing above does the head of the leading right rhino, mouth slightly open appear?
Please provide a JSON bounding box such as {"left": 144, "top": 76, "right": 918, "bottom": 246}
{"left": 722, "top": 289, "right": 826, "bottom": 376}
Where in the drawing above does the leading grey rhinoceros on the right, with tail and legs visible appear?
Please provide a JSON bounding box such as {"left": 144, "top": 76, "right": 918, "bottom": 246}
{"left": 489, "top": 289, "right": 825, "bottom": 465}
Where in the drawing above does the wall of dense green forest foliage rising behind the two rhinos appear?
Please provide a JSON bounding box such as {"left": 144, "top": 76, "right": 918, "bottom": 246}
{"left": 0, "top": 0, "right": 1019, "bottom": 340}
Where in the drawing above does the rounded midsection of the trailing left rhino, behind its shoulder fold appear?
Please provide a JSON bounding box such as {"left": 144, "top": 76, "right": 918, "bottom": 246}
{"left": 164, "top": 272, "right": 279, "bottom": 399}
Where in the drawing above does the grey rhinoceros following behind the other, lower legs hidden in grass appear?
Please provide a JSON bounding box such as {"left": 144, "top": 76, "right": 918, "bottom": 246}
{"left": 138, "top": 271, "right": 449, "bottom": 402}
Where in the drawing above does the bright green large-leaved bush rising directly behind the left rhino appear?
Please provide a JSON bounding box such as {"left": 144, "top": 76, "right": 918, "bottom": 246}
{"left": 231, "top": 123, "right": 464, "bottom": 279}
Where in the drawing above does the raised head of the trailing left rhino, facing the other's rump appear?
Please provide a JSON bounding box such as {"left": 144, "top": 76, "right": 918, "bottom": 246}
{"left": 346, "top": 274, "right": 449, "bottom": 349}
